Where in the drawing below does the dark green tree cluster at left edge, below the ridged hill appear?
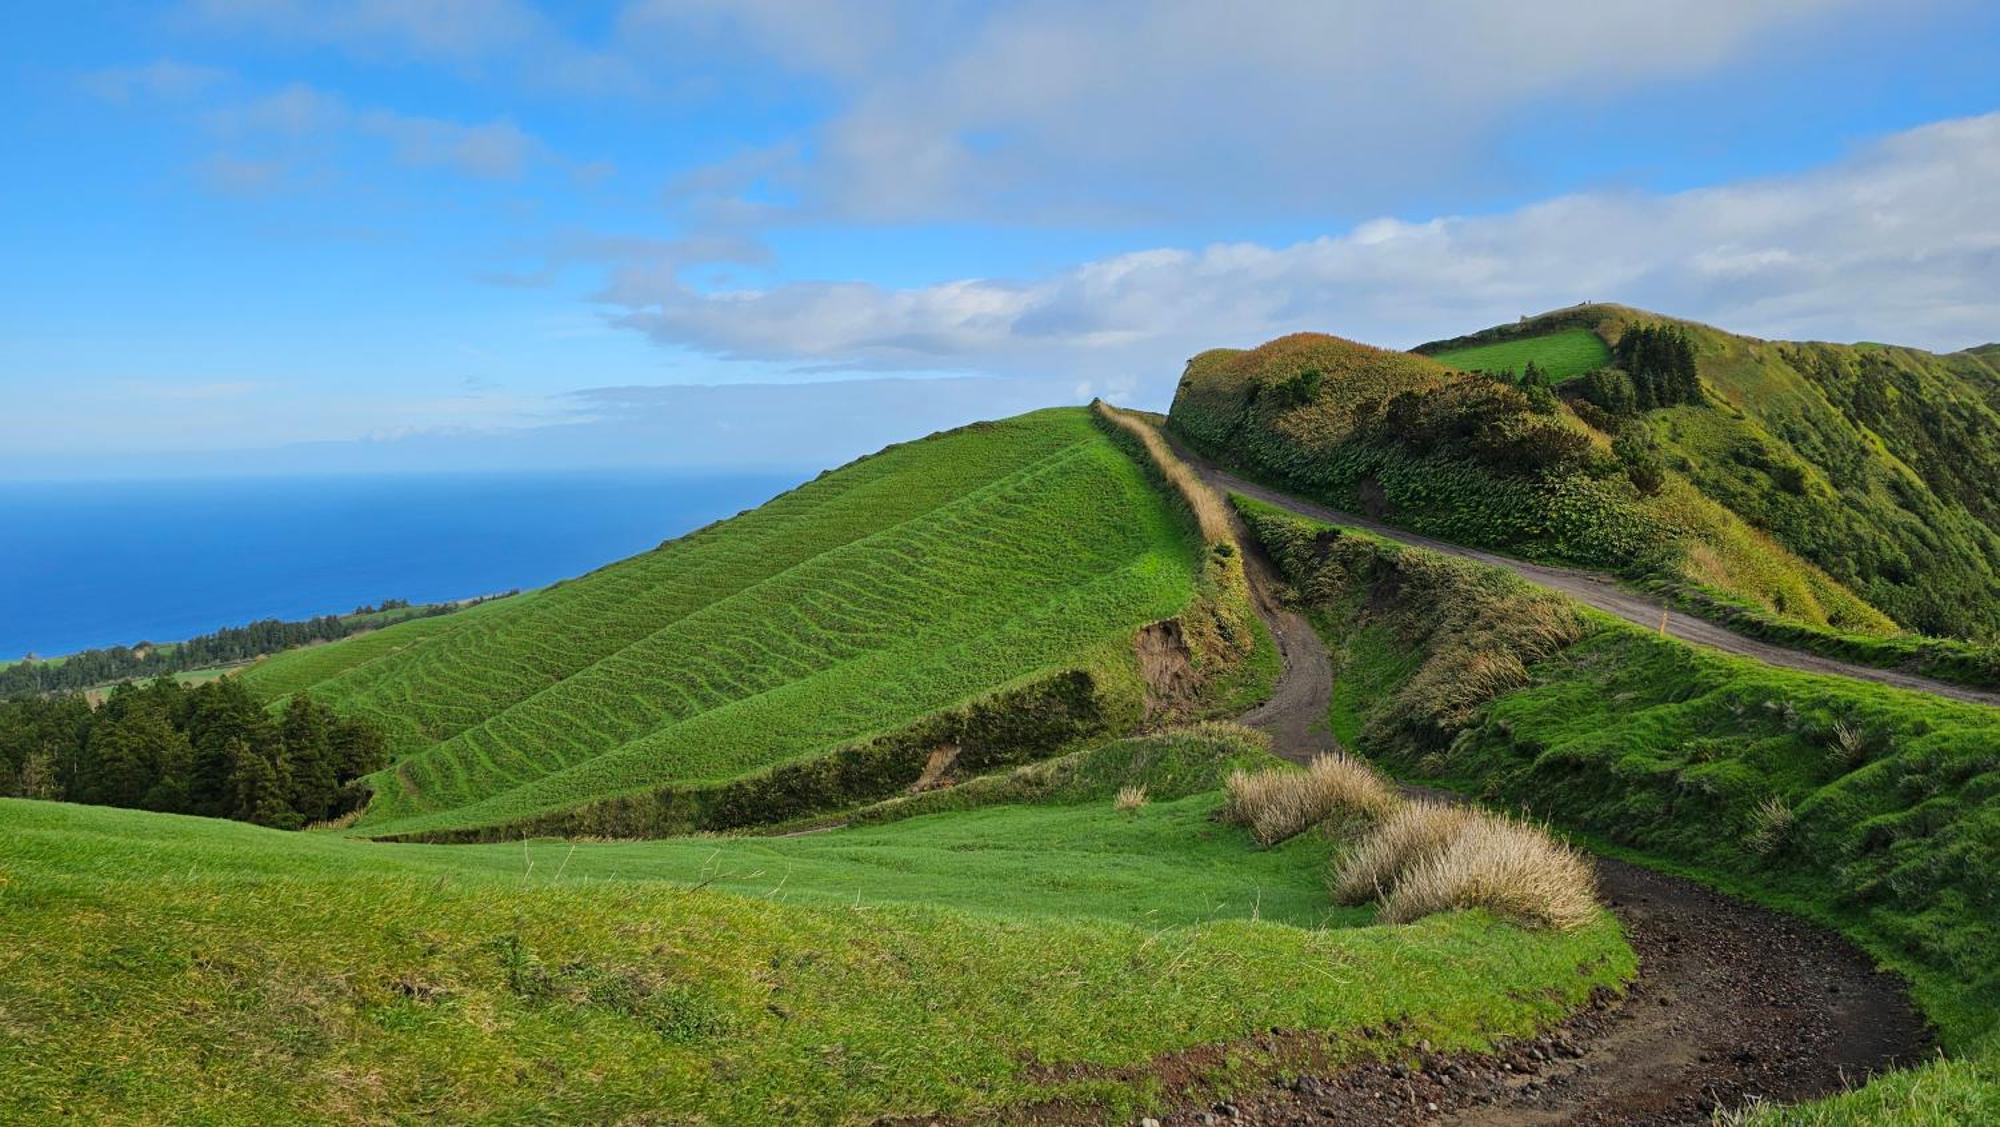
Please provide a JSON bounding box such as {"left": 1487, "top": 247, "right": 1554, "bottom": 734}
{"left": 0, "top": 677, "right": 388, "bottom": 829}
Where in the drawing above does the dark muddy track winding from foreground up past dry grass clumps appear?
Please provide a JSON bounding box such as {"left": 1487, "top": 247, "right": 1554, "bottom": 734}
{"left": 1164, "top": 476, "right": 1930, "bottom": 1125}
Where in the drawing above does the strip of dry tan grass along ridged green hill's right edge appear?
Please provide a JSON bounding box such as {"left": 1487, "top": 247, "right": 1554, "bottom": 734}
{"left": 1090, "top": 400, "right": 1256, "bottom": 713}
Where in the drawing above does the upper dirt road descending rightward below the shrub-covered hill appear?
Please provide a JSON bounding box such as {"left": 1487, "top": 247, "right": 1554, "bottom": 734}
{"left": 1182, "top": 461, "right": 2000, "bottom": 707}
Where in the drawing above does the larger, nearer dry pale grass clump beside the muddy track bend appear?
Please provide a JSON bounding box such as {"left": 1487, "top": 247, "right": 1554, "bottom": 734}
{"left": 1380, "top": 813, "right": 1598, "bottom": 931}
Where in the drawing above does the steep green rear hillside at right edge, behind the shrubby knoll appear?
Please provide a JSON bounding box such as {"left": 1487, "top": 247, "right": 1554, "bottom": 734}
{"left": 1420, "top": 306, "right": 2000, "bottom": 641}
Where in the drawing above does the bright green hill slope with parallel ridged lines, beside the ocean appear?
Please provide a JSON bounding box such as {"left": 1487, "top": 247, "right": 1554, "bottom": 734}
{"left": 246, "top": 410, "right": 1198, "bottom": 835}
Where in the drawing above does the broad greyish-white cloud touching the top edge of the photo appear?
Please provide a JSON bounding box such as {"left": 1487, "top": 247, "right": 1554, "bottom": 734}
{"left": 626, "top": 0, "right": 1888, "bottom": 222}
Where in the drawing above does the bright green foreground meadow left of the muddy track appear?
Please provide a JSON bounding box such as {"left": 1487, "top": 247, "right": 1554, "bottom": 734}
{"left": 0, "top": 725, "right": 1632, "bottom": 1123}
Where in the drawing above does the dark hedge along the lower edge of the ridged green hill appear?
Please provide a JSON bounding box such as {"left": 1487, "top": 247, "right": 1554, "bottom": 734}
{"left": 368, "top": 667, "right": 1142, "bottom": 843}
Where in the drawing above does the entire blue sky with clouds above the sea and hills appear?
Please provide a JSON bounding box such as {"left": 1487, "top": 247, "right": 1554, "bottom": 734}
{"left": 0, "top": 0, "right": 2000, "bottom": 476}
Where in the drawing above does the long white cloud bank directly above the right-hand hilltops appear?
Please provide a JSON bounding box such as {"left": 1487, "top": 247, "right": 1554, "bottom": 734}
{"left": 606, "top": 114, "right": 2000, "bottom": 388}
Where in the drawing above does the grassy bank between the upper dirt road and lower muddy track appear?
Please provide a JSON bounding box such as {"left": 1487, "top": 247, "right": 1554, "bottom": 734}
{"left": 1240, "top": 502, "right": 2000, "bottom": 1121}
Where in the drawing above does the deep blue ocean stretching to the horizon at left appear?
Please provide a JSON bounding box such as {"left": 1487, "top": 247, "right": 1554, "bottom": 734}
{"left": 0, "top": 472, "right": 800, "bottom": 661}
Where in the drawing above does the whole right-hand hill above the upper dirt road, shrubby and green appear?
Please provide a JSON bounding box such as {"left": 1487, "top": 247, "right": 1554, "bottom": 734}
{"left": 1170, "top": 306, "right": 2000, "bottom": 687}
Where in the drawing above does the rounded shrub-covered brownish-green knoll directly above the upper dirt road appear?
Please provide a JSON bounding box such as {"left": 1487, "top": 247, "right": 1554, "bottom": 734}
{"left": 1170, "top": 334, "right": 1894, "bottom": 635}
